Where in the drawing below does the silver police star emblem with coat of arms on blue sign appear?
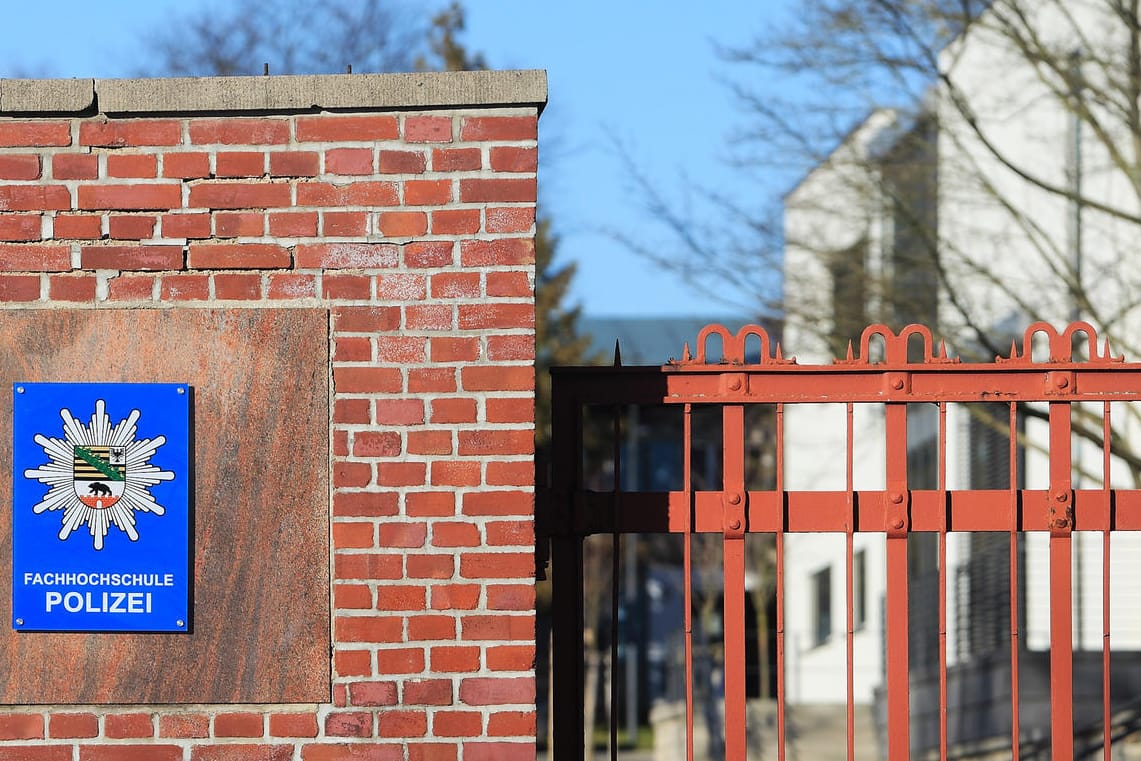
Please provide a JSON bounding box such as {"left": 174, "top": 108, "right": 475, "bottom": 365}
{"left": 24, "top": 399, "right": 175, "bottom": 550}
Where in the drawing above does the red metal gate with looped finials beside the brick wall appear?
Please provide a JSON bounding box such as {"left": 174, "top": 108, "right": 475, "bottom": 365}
{"left": 539, "top": 323, "right": 1141, "bottom": 761}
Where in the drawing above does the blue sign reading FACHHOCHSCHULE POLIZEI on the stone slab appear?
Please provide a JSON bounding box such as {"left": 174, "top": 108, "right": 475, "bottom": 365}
{"left": 11, "top": 383, "right": 191, "bottom": 632}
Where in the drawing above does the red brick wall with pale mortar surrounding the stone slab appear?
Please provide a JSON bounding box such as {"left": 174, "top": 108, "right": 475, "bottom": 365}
{"left": 0, "top": 75, "right": 537, "bottom": 761}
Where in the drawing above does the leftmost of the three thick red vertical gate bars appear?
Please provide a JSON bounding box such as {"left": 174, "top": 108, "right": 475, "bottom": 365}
{"left": 721, "top": 404, "right": 746, "bottom": 759}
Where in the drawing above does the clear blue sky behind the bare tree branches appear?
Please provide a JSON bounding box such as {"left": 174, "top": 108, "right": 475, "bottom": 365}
{"left": 0, "top": 0, "right": 785, "bottom": 318}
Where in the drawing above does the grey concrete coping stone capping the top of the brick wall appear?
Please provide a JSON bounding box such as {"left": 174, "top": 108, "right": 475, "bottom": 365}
{"left": 0, "top": 70, "right": 547, "bottom": 115}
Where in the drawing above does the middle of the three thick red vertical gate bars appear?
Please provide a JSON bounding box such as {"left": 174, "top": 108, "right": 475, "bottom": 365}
{"left": 884, "top": 403, "right": 911, "bottom": 761}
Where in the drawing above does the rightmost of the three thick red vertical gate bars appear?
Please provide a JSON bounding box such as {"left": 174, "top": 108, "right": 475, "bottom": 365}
{"left": 1049, "top": 402, "right": 1074, "bottom": 761}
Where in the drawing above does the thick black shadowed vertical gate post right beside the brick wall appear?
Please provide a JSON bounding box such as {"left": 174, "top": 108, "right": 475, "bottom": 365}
{"left": 550, "top": 387, "right": 586, "bottom": 761}
